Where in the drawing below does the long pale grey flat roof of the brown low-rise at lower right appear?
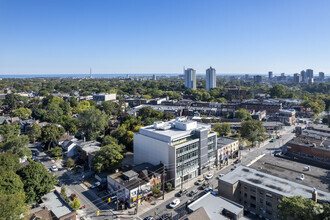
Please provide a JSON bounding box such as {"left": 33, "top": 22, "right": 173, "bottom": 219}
{"left": 221, "top": 166, "right": 330, "bottom": 201}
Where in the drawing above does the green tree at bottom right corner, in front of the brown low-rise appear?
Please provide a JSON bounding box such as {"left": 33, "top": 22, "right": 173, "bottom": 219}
{"left": 279, "top": 196, "right": 323, "bottom": 220}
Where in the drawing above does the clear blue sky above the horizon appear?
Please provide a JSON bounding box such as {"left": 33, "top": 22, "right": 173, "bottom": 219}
{"left": 0, "top": 0, "right": 330, "bottom": 74}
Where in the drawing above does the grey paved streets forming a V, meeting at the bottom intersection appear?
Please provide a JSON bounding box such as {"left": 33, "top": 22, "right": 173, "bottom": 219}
{"left": 30, "top": 123, "right": 294, "bottom": 219}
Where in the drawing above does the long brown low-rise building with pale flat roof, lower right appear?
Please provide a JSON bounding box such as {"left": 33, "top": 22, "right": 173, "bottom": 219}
{"left": 218, "top": 166, "right": 330, "bottom": 219}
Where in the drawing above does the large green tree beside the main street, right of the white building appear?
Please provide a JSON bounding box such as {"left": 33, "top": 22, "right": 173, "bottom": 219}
{"left": 240, "top": 120, "right": 266, "bottom": 143}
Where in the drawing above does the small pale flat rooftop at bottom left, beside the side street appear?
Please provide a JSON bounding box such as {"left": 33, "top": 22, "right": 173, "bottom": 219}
{"left": 41, "top": 191, "right": 74, "bottom": 218}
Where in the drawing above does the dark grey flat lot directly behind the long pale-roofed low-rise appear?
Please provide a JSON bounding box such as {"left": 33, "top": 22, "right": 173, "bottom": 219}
{"left": 251, "top": 155, "right": 330, "bottom": 192}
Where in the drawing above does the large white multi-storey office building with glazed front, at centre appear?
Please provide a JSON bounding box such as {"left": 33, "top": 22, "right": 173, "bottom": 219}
{"left": 134, "top": 117, "right": 217, "bottom": 187}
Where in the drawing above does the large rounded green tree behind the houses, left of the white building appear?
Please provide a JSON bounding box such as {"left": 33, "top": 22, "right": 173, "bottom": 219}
{"left": 79, "top": 109, "right": 108, "bottom": 140}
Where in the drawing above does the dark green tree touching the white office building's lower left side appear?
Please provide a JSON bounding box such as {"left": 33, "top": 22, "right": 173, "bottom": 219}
{"left": 92, "top": 143, "right": 125, "bottom": 173}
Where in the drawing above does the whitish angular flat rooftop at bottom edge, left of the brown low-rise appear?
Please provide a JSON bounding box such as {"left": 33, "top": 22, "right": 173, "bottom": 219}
{"left": 188, "top": 192, "right": 244, "bottom": 220}
